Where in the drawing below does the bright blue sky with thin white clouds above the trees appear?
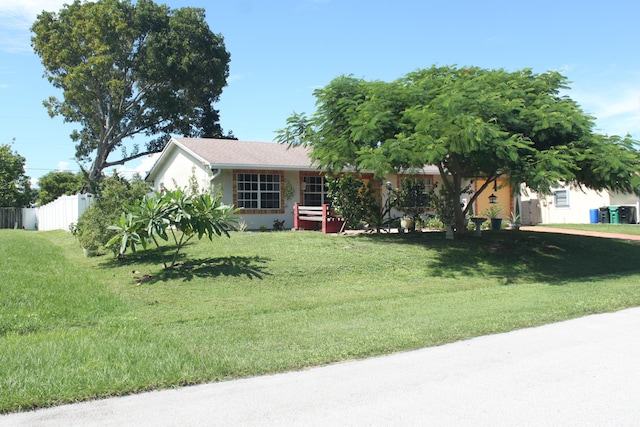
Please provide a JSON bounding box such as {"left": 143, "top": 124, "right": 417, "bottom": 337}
{"left": 0, "top": 0, "right": 640, "bottom": 186}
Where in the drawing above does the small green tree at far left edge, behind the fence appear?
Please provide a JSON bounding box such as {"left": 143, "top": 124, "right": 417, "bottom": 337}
{"left": 0, "top": 144, "right": 35, "bottom": 208}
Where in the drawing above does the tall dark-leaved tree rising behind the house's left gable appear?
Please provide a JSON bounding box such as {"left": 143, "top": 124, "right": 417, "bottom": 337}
{"left": 32, "top": 0, "right": 232, "bottom": 182}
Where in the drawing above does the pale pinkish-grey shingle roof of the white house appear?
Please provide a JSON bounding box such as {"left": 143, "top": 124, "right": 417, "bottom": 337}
{"left": 172, "top": 138, "right": 315, "bottom": 169}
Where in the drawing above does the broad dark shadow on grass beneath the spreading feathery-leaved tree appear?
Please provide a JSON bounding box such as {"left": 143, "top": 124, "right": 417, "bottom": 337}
{"left": 352, "top": 230, "right": 640, "bottom": 285}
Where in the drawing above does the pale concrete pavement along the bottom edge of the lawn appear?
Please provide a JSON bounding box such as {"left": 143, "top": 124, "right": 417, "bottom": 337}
{"left": 0, "top": 308, "right": 640, "bottom": 426}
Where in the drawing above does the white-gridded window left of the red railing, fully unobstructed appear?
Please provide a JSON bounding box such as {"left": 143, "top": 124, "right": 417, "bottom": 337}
{"left": 236, "top": 173, "right": 281, "bottom": 210}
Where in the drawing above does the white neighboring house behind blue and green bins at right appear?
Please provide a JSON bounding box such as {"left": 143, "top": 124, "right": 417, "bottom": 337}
{"left": 520, "top": 186, "right": 638, "bottom": 224}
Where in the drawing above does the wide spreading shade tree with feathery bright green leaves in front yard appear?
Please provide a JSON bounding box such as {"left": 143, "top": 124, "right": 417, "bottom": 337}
{"left": 277, "top": 66, "right": 640, "bottom": 236}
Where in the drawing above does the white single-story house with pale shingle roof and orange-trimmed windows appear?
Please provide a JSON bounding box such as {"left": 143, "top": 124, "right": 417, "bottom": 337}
{"left": 145, "top": 138, "right": 439, "bottom": 229}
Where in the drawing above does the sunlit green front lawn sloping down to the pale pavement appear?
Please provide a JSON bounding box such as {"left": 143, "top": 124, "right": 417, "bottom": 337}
{"left": 0, "top": 230, "right": 640, "bottom": 413}
